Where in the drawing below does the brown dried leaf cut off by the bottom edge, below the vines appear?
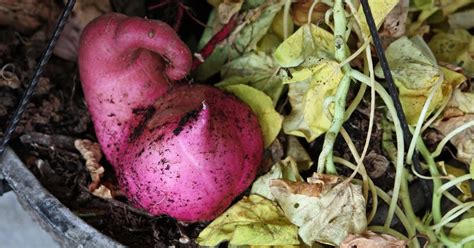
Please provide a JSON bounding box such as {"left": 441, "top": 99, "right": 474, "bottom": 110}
{"left": 340, "top": 231, "right": 407, "bottom": 248}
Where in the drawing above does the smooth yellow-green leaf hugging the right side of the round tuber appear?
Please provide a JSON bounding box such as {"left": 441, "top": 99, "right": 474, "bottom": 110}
{"left": 221, "top": 84, "right": 283, "bottom": 147}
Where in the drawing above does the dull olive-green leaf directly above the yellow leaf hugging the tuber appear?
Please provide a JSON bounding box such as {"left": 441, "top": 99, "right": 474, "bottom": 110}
{"left": 215, "top": 52, "right": 283, "bottom": 106}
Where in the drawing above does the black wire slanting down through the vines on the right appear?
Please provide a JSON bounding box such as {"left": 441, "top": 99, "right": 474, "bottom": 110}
{"left": 360, "top": 0, "right": 430, "bottom": 201}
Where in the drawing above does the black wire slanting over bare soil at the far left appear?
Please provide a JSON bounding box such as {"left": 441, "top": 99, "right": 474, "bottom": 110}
{"left": 0, "top": 0, "right": 76, "bottom": 156}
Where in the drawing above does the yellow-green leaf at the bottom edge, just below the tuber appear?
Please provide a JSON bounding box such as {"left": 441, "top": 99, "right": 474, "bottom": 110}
{"left": 197, "top": 195, "right": 300, "bottom": 246}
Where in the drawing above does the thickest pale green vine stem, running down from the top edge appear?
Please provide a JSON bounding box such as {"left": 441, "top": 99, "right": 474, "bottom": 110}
{"left": 318, "top": 0, "right": 351, "bottom": 174}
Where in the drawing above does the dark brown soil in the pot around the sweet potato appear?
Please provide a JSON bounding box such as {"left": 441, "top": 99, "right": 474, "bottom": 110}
{"left": 0, "top": 1, "right": 452, "bottom": 247}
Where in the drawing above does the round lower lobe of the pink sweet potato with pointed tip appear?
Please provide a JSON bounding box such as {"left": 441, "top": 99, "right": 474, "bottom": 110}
{"left": 119, "top": 85, "right": 263, "bottom": 221}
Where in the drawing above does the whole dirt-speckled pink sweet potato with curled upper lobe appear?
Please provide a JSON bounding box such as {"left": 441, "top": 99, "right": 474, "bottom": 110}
{"left": 79, "top": 14, "right": 263, "bottom": 222}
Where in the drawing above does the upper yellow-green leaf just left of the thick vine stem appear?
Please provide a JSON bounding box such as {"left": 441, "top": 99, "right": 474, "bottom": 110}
{"left": 274, "top": 24, "right": 334, "bottom": 67}
